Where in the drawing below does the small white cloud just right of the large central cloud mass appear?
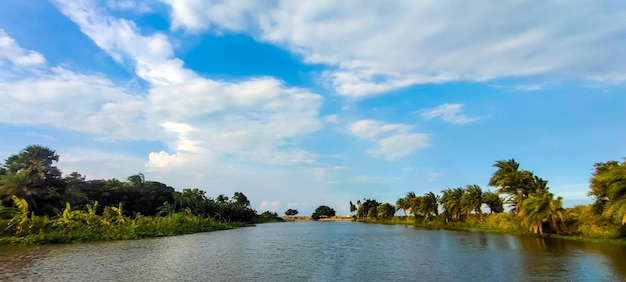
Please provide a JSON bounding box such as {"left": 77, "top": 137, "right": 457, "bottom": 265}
{"left": 349, "top": 120, "right": 429, "bottom": 160}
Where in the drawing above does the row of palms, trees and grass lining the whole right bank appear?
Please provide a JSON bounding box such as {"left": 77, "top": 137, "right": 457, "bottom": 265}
{"left": 350, "top": 159, "right": 626, "bottom": 239}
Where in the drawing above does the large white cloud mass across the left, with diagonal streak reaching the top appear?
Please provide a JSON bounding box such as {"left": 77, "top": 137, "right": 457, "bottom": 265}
{"left": 0, "top": 1, "right": 322, "bottom": 180}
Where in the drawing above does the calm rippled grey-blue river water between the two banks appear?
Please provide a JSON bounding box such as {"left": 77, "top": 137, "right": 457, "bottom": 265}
{"left": 0, "top": 222, "right": 626, "bottom": 281}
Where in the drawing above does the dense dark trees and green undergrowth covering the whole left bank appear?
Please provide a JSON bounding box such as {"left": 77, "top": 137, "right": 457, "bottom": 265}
{"left": 0, "top": 145, "right": 270, "bottom": 243}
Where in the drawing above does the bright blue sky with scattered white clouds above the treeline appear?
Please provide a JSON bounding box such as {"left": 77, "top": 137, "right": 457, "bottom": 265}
{"left": 0, "top": 0, "right": 626, "bottom": 215}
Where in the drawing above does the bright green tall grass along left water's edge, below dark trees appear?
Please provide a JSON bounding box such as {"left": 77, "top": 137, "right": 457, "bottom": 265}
{"left": 0, "top": 200, "right": 244, "bottom": 244}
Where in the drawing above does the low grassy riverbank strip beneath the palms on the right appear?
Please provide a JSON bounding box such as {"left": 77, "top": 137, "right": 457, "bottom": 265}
{"left": 357, "top": 216, "right": 626, "bottom": 246}
